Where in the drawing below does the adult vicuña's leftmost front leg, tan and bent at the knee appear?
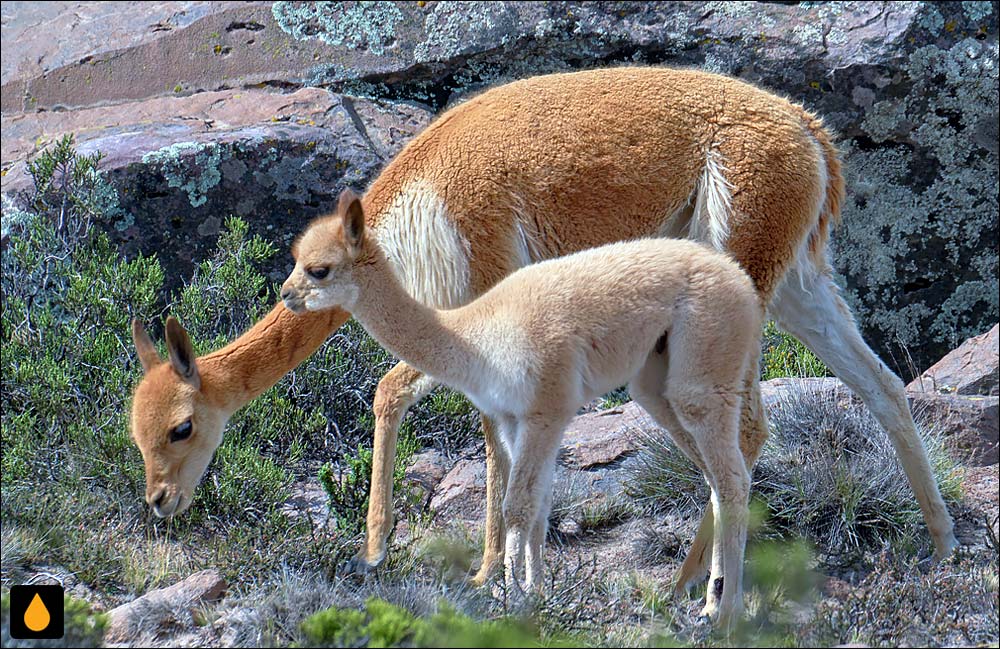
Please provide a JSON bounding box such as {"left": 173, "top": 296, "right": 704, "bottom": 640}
{"left": 347, "top": 363, "right": 435, "bottom": 573}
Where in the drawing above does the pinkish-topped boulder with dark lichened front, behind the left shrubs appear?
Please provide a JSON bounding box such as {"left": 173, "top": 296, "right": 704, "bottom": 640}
{"left": 3, "top": 88, "right": 430, "bottom": 287}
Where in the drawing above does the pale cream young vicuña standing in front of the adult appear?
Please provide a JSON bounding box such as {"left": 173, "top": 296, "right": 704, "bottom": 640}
{"left": 281, "top": 191, "right": 763, "bottom": 625}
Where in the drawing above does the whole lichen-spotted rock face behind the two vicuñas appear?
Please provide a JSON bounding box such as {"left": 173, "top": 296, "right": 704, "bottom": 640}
{"left": 2, "top": 2, "right": 1000, "bottom": 367}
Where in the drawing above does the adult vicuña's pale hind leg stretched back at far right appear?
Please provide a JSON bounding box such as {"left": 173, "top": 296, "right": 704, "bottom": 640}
{"left": 771, "top": 266, "right": 958, "bottom": 559}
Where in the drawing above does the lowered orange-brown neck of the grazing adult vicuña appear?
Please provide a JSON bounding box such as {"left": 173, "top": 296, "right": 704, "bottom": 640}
{"left": 197, "top": 302, "right": 351, "bottom": 412}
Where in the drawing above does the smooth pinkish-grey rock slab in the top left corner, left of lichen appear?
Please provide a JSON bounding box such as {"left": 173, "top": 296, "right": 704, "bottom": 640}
{"left": 2, "top": 2, "right": 332, "bottom": 113}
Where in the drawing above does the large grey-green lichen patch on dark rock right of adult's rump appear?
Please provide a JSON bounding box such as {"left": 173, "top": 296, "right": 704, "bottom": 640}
{"left": 834, "top": 38, "right": 1000, "bottom": 348}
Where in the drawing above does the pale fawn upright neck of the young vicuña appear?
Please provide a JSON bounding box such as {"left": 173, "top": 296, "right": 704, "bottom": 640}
{"left": 353, "top": 245, "right": 470, "bottom": 386}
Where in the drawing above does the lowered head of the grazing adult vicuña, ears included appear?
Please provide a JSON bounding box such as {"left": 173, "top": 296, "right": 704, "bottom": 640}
{"left": 131, "top": 317, "right": 230, "bottom": 518}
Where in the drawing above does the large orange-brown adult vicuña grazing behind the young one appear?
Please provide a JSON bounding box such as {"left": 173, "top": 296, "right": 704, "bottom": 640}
{"left": 132, "top": 67, "right": 956, "bottom": 587}
